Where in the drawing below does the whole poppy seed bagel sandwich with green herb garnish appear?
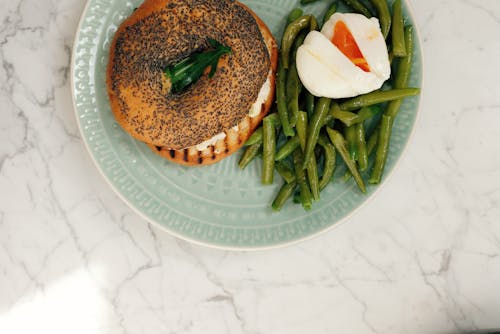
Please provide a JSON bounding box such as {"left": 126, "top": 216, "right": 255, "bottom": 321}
{"left": 107, "top": 0, "right": 277, "bottom": 165}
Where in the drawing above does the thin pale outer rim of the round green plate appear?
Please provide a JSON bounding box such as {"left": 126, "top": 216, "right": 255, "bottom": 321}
{"left": 70, "top": 0, "right": 425, "bottom": 252}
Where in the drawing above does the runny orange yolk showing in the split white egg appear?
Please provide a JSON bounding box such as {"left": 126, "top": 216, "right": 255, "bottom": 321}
{"left": 331, "top": 21, "right": 371, "bottom": 72}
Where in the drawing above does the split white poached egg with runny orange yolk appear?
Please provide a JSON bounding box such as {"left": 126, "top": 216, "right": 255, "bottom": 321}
{"left": 296, "top": 13, "right": 391, "bottom": 98}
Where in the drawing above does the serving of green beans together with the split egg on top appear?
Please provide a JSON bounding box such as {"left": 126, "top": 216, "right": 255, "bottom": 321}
{"left": 239, "top": 0, "right": 420, "bottom": 211}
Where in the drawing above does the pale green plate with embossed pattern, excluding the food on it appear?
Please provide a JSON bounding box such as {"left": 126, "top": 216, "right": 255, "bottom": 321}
{"left": 71, "top": 0, "right": 422, "bottom": 249}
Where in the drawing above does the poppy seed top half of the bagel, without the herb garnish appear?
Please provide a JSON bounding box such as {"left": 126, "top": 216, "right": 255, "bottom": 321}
{"left": 107, "top": 0, "right": 271, "bottom": 150}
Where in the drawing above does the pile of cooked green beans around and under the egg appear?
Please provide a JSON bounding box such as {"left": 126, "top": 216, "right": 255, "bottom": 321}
{"left": 239, "top": 0, "right": 420, "bottom": 211}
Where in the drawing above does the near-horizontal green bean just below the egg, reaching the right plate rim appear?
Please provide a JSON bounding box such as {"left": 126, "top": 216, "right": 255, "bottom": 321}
{"left": 340, "top": 88, "right": 420, "bottom": 111}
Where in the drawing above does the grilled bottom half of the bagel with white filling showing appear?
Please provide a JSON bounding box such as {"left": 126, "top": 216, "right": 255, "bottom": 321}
{"left": 148, "top": 5, "right": 278, "bottom": 166}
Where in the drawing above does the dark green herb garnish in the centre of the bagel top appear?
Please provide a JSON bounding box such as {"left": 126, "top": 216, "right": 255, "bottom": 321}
{"left": 165, "top": 38, "right": 231, "bottom": 94}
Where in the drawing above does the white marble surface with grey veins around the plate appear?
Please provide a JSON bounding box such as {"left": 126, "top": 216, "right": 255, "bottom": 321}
{"left": 0, "top": 0, "right": 500, "bottom": 334}
